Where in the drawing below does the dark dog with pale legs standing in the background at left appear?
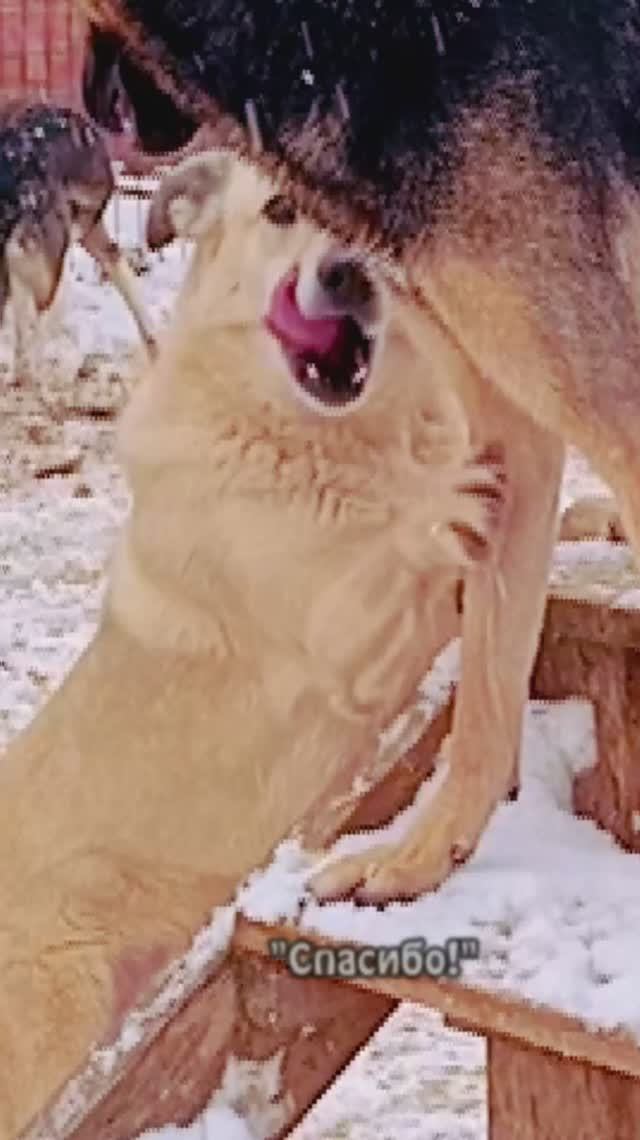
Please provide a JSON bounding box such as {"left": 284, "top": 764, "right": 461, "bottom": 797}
{"left": 0, "top": 101, "right": 153, "bottom": 380}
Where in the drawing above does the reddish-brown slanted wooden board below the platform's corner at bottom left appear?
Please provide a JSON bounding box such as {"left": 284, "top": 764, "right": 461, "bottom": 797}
{"left": 31, "top": 948, "right": 396, "bottom": 1140}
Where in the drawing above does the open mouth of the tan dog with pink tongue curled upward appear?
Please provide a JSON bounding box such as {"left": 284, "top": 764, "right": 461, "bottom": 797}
{"left": 265, "top": 272, "right": 374, "bottom": 410}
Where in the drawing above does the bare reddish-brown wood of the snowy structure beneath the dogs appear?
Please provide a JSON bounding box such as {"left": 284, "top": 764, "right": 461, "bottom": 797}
{"left": 13, "top": 547, "right": 640, "bottom": 1140}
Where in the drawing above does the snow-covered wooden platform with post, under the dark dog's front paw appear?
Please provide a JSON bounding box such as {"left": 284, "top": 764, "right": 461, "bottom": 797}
{"left": 231, "top": 684, "right": 640, "bottom": 1140}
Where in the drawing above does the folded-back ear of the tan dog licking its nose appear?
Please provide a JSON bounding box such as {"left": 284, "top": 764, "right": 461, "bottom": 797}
{"left": 146, "top": 150, "right": 234, "bottom": 250}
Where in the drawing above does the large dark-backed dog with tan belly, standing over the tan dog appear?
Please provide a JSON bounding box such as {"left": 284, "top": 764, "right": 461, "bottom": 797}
{"left": 78, "top": 0, "right": 640, "bottom": 893}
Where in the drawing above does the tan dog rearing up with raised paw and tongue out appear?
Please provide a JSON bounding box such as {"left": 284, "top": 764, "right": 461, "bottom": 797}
{"left": 0, "top": 155, "right": 527, "bottom": 1140}
